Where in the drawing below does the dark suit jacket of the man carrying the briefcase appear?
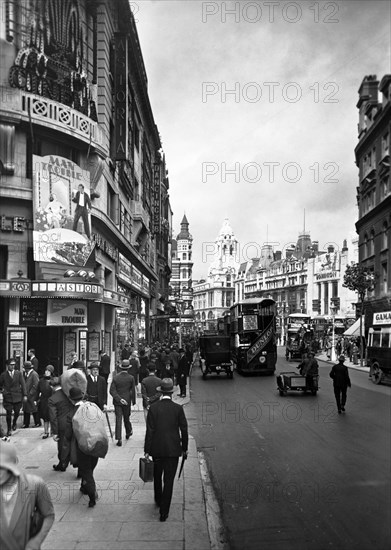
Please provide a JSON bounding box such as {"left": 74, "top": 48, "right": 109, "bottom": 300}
{"left": 144, "top": 398, "right": 189, "bottom": 458}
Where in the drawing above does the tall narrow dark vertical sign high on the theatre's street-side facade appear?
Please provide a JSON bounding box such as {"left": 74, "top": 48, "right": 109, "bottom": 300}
{"left": 114, "top": 33, "right": 129, "bottom": 160}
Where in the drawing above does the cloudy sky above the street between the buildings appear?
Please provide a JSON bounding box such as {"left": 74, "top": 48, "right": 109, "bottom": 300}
{"left": 134, "top": 0, "right": 390, "bottom": 279}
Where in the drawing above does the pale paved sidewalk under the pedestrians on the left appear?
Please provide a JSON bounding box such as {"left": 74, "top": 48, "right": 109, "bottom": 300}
{"left": 2, "top": 388, "right": 211, "bottom": 550}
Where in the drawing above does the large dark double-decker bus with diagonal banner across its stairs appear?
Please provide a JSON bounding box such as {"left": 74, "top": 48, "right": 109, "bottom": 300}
{"left": 230, "top": 298, "right": 277, "bottom": 374}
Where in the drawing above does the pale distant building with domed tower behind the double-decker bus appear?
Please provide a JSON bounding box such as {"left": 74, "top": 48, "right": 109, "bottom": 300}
{"left": 193, "top": 218, "right": 239, "bottom": 333}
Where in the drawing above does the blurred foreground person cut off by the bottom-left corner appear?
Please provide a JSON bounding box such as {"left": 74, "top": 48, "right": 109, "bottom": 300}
{"left": 0, "top": 441, "right": 54, "bottom": 550}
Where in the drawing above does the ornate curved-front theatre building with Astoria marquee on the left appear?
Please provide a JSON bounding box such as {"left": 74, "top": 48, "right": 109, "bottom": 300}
{"left": 0, "top": 0, "right": 171, "bottom": 373}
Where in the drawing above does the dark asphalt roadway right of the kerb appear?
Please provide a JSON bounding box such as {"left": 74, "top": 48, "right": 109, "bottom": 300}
{"left": 187, "top": 348, "right": 391, "bottom": 550}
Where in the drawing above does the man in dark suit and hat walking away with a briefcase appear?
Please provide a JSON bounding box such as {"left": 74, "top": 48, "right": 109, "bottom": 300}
{"left": 144, "top": 378, "right": 189, "bottom": 521}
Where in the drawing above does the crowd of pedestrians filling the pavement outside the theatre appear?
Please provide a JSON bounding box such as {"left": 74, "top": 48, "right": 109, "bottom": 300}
{"left": 0, "top": 344, "right": 193, "bottom": 550}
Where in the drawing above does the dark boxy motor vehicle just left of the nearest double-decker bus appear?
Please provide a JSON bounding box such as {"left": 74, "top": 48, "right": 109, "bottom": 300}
{"left": 199, "top": 335, "right": 234, "bottom": 380}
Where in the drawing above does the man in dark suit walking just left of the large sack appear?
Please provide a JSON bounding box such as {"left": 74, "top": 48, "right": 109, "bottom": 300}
{"left": 48, "top": 378, "right": 74, "bottom": 472}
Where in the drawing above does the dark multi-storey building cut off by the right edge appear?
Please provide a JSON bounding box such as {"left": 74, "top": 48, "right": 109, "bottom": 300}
{"left": 355, "top": 74, "right": 391, "bottom": 329}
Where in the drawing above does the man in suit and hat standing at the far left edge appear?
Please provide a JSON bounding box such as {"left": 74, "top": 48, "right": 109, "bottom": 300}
{"left": 0, "top": 359, "right": 27, "bottom": 436}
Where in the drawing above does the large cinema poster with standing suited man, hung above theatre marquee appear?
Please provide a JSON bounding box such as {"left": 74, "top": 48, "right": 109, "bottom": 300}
{"left": 33, "top": 155, "right": 94, "bottom": 267}
